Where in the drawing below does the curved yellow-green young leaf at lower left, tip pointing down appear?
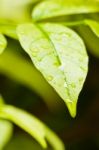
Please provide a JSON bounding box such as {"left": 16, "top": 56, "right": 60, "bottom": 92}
{"left": 0, "top": 105, "right": 47, "bottom": 148}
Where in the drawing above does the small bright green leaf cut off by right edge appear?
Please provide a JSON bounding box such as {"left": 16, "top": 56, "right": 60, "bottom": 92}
{"left": 84, "top": 19, "right": 99, "bottom": 37}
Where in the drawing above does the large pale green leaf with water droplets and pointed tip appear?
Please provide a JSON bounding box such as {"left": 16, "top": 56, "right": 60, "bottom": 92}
{"left": 17, "top": 23, "right": 88, "bottom": 117}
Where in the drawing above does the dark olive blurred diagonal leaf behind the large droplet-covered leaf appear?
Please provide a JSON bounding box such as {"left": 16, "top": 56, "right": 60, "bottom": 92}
{"left": 0, "top": 47, "right": 61, "bottom": 111}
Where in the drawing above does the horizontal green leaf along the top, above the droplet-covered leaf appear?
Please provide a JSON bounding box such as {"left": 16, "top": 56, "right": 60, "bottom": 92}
{"left": 32, "top": 0, "right": 99, "bottom": 21}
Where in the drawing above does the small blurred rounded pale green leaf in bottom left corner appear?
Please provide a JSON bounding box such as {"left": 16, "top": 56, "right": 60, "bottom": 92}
{"left": 0, "top": 120, "right": 13, "bottom": 150}
